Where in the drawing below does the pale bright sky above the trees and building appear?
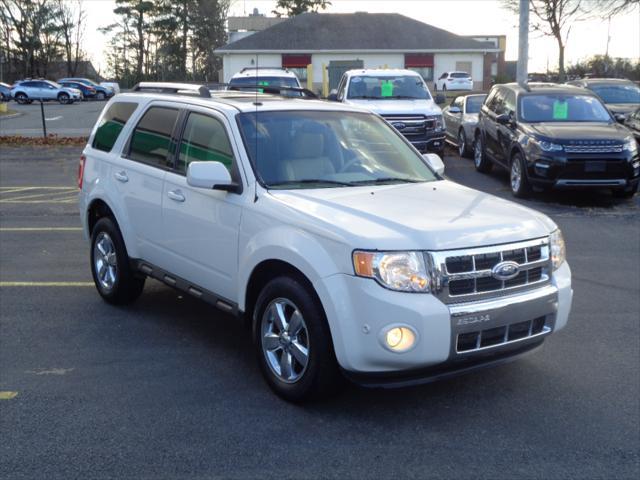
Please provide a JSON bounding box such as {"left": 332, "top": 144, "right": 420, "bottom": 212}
{"left": 83, "top": 0, "right": 640, "bottom": 73}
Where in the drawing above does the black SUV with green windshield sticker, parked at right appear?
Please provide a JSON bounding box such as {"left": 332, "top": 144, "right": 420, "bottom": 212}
{"left": 474, "top": 83, "right": 640, "bottom": 198}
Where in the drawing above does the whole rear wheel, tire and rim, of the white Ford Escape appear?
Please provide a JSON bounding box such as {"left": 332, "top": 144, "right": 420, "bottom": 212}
{"left": 91, "top": 217, "right": 145, "bottom": 305}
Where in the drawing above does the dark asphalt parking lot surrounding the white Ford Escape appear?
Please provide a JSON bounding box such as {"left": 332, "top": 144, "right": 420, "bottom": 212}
{"left": 0, "top": 144, "right": 640, "bottom": 479}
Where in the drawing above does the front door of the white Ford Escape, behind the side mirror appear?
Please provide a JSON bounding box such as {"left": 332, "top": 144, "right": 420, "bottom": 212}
{"left": 161, "top": 107, "right": 242, "bottom": 299}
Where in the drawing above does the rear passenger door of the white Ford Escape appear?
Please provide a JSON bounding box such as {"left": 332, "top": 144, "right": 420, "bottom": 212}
{"left": 111, "top": 102, "right": 180, "bottom": 266}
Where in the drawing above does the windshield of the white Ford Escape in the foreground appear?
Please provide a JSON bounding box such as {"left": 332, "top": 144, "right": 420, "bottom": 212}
{"left": 238, "top": 111, "right": 437, "bottom": 189}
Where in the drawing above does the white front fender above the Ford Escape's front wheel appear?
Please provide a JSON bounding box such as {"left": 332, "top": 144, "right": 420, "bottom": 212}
{"left": 237, "top": 225, "right": 350, "bottom": 311}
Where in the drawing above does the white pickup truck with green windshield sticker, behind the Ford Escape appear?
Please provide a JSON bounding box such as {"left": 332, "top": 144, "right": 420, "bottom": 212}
{"left": 328, "top": 69, "right": 445, "bottom": 154}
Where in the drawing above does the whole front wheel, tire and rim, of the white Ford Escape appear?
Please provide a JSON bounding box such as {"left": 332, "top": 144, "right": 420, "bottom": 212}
{"left": 254, "top": 276, "right": 340, "bottom": 402}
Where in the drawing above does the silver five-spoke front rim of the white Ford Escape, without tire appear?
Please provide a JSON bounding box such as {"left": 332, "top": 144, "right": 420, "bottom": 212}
{"left": 261, "top": 298, "right": 309, "bottom": 383}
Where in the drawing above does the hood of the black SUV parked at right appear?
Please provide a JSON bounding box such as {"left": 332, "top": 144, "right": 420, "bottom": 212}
{"left": 527, "top": 122, "right": 629, "bottom": 143}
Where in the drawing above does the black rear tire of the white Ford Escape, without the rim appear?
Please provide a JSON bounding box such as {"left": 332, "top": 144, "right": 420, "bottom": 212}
{"left": 91, "top": 217, "right": 145, "bottom": 305}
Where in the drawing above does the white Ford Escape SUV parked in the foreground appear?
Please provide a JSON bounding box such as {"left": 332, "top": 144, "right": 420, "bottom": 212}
{"left": 78, "top": 81, "right": 572, "bottom": 401}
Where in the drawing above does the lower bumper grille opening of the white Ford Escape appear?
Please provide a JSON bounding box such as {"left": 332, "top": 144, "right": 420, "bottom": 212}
{"left": 456, "top": 317, "right": 551, "bottom": 353}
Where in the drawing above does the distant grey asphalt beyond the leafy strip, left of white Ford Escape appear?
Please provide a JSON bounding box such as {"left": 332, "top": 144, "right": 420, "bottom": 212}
{"left": 0, "top": 100, "right": 106, "bottom": 137}
